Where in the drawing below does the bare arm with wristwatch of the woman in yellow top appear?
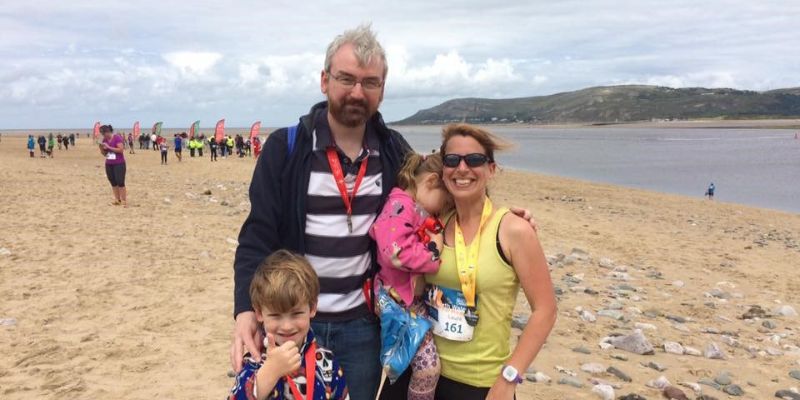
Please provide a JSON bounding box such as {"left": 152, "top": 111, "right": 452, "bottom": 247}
{"left": 487, "top": 215, "right": 556, "bottom": 399}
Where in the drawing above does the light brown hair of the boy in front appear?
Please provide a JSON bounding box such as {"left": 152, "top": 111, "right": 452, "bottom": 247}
{"left": 250, "top": 250, "right": 319, "bottom": 313}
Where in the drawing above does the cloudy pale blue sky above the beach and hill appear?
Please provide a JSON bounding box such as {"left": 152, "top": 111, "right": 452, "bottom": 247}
{"left": 0, "top": 0, "right": 800, "bottom": 129}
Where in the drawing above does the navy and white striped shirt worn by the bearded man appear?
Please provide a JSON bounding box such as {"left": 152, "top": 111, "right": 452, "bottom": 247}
{"left": 305, "top": 113, "right": 382, "bottom": 321}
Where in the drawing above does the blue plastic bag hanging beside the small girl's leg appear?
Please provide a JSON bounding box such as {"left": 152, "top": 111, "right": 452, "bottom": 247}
{"left": 376, "top": 287, "right": 431, "bottom": 383}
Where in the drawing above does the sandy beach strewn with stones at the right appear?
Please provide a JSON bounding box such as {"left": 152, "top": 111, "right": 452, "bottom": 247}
{"left": 0, "top": 135, "right": 800, "bottom": 399}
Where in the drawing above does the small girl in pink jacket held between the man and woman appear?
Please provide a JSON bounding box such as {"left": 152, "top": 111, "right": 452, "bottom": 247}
{"left": 369, "top": 153, "right": 450, "bottom": 400}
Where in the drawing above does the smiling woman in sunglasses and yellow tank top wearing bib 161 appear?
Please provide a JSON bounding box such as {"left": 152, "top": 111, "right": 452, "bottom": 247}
{"left": 386, "top": 124, "right": 556, "bottom": 400}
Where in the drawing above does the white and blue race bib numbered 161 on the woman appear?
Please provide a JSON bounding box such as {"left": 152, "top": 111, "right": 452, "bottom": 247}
{"left": 425, "top": 285, "right": 478, "bottom": 342}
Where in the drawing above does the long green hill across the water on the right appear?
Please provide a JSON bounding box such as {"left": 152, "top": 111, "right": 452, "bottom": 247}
{"left": 395, "top": 85, "right": 800, "bottom": 124}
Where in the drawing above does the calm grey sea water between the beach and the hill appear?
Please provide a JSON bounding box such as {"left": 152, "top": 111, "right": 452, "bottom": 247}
{"left": 0, "top": 126, "right": 800, "bottom": 213}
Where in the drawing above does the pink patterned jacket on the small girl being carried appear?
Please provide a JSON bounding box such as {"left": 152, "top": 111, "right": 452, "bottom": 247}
{"left": 369, "top": 188, "right": 439, "bottom": 306}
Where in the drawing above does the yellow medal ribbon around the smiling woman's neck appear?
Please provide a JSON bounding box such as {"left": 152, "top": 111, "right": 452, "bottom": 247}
{"left": 455, "top": 197, "right": 492, "bottom": 326}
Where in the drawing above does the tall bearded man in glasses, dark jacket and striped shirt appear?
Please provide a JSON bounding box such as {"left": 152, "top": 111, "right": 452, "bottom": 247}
{"left": 231, "top": 26, "right": 410, "bottom": 400}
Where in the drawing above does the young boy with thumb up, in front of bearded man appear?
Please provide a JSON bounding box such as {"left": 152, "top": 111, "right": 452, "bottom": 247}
{"left": 229, "top": 250, "right": 350, "bottom": 400}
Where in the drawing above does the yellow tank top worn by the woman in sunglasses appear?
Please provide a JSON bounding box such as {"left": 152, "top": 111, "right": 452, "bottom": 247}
{"left": 425, "top": 208, "right": 519, "bottom": 387}
